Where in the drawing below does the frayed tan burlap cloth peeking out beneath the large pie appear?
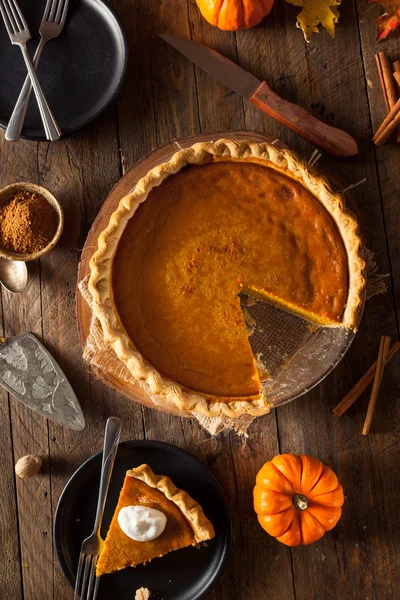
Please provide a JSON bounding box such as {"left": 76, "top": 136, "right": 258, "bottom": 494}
{"left": 78, "top": 250, "right": 387, "bottom": 436}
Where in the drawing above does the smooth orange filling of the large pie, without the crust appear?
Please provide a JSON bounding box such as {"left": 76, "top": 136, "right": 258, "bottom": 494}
{"left": 112, "top": 161, "right": 348, "bottom": 398}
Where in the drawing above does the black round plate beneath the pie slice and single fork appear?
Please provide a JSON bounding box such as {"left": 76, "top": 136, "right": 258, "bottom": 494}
{"left": 54, "top": 441, "right": 231, "bottom": 600}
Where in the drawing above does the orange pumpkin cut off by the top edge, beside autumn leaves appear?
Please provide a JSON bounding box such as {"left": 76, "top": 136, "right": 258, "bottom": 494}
{"left": 196, "top": 0, "right": 274, "bottom": 31}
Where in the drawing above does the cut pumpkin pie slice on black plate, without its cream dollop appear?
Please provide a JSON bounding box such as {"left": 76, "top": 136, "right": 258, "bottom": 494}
{"left": 96, "top": 465, "right": 215, "bottom": 577}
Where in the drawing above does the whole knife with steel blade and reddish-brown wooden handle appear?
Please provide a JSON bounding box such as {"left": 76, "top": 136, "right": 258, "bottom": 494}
{"left": 160, "top": 34, "right": 358, "bottom": 158}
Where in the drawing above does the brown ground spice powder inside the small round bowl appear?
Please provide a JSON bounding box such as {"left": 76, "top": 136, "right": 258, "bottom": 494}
{"left": 0, "top": 191, "right": 58, "bottom": 254}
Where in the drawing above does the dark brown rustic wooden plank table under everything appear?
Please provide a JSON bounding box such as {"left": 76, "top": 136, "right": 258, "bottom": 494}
{"left": 0, "top": 0, "right": 400, "bottom": 600}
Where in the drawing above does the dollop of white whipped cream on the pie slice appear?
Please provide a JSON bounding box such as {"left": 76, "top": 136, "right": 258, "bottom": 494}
{"left": 118, "top": 506, "right": 167, "bottom": 542}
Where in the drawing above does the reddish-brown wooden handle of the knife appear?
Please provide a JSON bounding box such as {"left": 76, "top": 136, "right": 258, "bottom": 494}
{"left": 250, "top": 81, "right": 358, "bottom": 158}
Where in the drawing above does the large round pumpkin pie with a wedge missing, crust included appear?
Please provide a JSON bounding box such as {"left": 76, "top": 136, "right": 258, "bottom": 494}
{"left": 89, "top": 140, "right": 365, "bottom": 417}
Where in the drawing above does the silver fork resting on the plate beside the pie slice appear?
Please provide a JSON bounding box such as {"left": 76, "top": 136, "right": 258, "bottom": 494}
{"left": 74, "top": 417, "right": 122, "bottom": 600}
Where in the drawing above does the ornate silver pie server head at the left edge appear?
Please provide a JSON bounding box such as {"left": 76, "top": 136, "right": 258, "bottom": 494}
{"left": 0, "top": 332, "right": 85, "bottom": 431}
